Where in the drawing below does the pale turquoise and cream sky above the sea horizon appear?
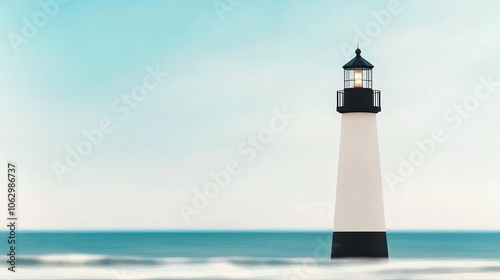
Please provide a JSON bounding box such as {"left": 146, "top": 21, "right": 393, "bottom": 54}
{"left": 0, "top": 0, "right": 500, "bottom": 230}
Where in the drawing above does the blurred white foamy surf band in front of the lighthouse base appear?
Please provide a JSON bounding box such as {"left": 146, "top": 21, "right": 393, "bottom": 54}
{"left": 0, "top": 254, "right": 500, "bottom": 280}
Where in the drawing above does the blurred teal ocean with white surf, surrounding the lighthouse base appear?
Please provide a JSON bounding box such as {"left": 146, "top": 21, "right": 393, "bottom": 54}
{"left": 0, "top": 231, "right": 500, "bottom": 280}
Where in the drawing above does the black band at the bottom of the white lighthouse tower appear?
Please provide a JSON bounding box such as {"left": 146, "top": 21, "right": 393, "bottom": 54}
{"left": 332, "top": 231, "right": 389, "bottom": 259}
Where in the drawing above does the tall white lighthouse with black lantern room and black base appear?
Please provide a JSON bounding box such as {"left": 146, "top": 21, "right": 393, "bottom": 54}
{"left": 331, "top": 48, "right": 388, "bottom": 259}
